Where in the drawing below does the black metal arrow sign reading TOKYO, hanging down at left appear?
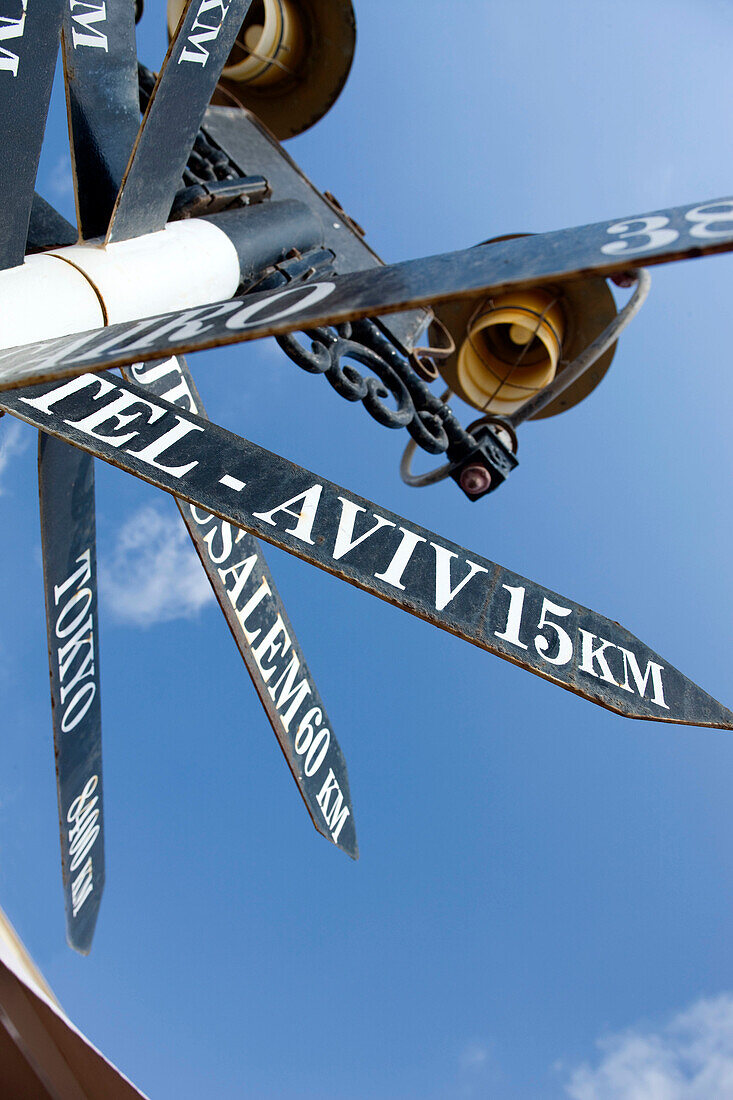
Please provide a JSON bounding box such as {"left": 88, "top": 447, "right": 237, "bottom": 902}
{"left": 39, "top": 432, "right": 105, "bottom": 955}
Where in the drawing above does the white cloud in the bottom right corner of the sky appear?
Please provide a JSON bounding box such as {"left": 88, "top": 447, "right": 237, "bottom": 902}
{"left": 566, "top": 993, "right": 733, "bottom": 1100}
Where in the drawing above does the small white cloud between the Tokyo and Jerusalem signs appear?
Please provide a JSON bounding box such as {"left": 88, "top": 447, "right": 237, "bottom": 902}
{"left": 99, "top": 506, "right": 214, "bottom": 626}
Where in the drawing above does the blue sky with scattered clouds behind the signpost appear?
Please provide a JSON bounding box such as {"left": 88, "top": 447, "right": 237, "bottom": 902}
{"left": 0, "top": 0, "right": 733, "bottom": 1100}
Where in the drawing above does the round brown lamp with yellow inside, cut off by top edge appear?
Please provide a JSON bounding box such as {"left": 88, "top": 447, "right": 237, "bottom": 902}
{"left": 167, "top": 0, "right": 357, "bottom": 141}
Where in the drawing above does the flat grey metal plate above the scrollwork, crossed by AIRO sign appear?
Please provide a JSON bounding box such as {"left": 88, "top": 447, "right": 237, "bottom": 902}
{"left": 204, "top": 107, "right": 430, "bottom": 351}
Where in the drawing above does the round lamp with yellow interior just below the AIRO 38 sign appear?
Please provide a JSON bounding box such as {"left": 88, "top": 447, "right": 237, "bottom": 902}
{"left": 434, "top": 233, "right": 616, "bottom": 420}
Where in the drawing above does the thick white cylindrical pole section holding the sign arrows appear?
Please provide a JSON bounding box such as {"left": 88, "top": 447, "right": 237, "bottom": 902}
{"left": 0, "top": 218, "right": 240, "bottom": 348}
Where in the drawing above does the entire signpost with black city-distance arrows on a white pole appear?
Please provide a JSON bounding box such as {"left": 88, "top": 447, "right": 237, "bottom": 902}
{"left": 0, "top": 0, "right": 733, "bottom": 952}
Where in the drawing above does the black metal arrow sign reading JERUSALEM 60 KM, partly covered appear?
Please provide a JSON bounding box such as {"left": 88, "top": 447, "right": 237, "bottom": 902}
{"left": 125, "top": 359, "right": 359, "bottom": 859}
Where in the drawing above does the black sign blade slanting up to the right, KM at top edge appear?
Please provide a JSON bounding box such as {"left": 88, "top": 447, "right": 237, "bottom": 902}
{"left": 107, "top": 0, "right": 251, "bottom": 241}
